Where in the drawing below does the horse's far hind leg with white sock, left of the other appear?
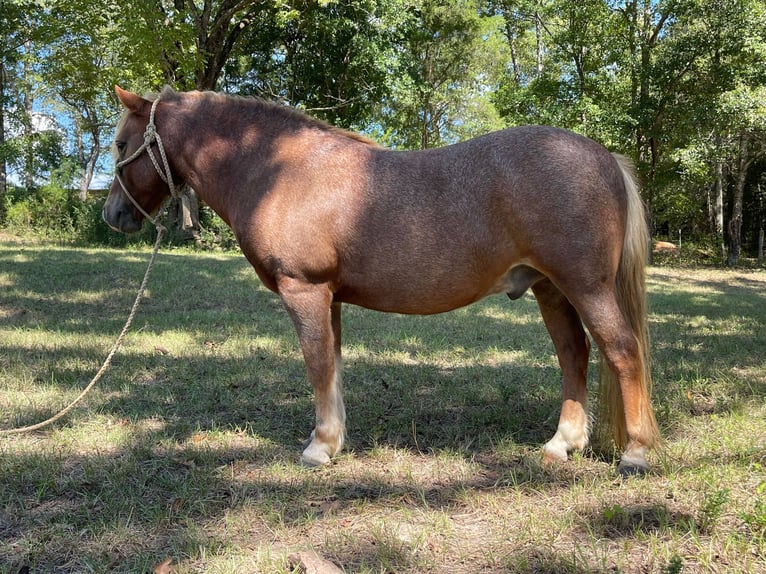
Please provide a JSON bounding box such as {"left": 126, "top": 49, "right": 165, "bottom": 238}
{"left": 532, "top": 279, "right": 590, "bottom": 462}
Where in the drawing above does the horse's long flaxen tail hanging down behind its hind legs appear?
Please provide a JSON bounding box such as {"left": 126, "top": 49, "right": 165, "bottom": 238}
{"left": 598, "top": 154, "right": 660, "bottom": 456}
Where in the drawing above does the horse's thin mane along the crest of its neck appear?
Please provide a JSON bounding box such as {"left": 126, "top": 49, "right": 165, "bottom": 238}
{"left": 157, "top": 86, "right": 379, "bottom": 147}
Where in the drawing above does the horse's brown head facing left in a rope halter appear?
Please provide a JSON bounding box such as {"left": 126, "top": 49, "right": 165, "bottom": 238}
{"left": 102, "top": 86, "right": 175, "bottom": 233}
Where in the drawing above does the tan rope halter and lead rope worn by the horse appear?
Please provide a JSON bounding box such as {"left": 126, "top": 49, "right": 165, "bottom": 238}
{"left": 0, "top": 98, "right": 179, "bottom": 436}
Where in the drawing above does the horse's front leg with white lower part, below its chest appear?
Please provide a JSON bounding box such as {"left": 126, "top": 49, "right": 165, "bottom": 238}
{"left": 278, "top": 278, "right": 346, "bottom": 466}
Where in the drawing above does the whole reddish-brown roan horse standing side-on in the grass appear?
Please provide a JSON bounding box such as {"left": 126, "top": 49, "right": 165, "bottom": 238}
{"left": 103, "top": 87, "right": 659, "bottom": 473}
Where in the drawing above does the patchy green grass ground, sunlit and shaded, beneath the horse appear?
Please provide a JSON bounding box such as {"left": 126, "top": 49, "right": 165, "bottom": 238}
{"left": 0, "top": 237, "right": 766, "bottom": 574}
